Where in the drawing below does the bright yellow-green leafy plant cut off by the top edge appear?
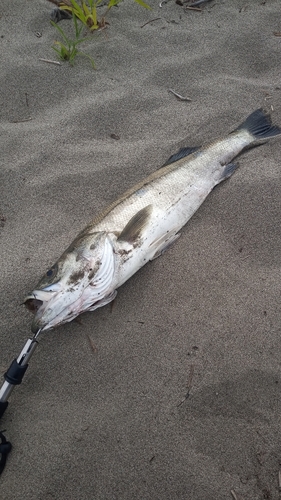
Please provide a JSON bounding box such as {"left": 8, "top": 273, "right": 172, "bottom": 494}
{"left": 60, "top": 0, "right": 151, "bottom": 30}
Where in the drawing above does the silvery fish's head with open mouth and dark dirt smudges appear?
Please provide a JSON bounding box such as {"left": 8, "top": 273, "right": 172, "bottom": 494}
{"left": 24, "top": 231, "right": 115, "bottom": 333}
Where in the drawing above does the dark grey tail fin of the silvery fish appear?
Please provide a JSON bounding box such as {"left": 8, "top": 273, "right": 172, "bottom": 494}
{"left": 236, "top": 108, "right": 281, "bottom": 140}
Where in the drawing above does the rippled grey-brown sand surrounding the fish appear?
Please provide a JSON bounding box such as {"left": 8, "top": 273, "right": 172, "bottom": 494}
{"left": 0, "top": 0, "right": 281, "bottom": 500}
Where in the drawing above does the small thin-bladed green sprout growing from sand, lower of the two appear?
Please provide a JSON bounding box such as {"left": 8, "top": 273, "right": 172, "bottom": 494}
{"left": 51, "top": 13, "right": 95, "bottom": 68}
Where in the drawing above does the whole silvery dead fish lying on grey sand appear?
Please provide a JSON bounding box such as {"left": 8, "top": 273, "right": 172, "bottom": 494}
{"left": 24, "top": 109, "right": 281, "bottom": 333}
